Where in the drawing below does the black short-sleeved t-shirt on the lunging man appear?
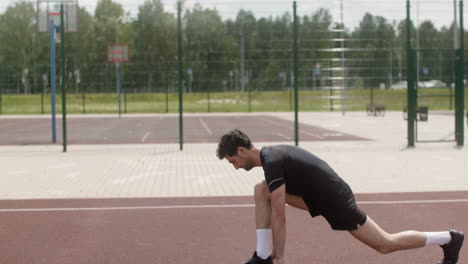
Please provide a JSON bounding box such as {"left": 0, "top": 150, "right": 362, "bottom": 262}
{"left": 260, "top": 145, "right": 352, "bottom": 215}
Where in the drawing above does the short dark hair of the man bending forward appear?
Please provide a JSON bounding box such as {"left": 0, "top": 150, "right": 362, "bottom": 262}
{"left": 216, "top": 129, "right": 252, "bottom": 159}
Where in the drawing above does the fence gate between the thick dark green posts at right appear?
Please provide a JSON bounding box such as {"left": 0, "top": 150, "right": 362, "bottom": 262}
{"left": 404, "top": 0, "right": 465, "bottom": 147}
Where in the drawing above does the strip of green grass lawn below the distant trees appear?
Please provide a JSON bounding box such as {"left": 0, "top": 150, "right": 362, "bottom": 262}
{"left": 0, "top": 88, "right": 468, "bottom": 115}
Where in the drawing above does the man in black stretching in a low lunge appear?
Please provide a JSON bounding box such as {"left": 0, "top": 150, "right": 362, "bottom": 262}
{"left": 217, "top": 129, "right": 464, "bottom": 264}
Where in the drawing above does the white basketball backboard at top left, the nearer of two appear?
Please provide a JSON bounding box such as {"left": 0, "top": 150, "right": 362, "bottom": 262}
{"left": 37, "top": 0, "right": 78, "bottom": 32}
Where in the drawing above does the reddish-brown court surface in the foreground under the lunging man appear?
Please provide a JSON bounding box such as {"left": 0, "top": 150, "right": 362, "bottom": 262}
{"left": 0, "top": 191, "right": 468, "bottom": 264}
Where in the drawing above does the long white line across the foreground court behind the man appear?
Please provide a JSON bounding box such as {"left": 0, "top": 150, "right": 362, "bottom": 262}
{"left": 0, "top": 199, "right": 468, "bottom": 213}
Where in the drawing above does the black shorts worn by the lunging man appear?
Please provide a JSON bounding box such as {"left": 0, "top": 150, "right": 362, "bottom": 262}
{"left": 304, "top": 192, "right": 367, "bottom": 231}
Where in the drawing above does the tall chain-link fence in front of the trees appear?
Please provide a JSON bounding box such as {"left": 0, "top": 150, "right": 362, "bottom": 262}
{"left": 0, "top": 0, "right": 466, "bottom": 144}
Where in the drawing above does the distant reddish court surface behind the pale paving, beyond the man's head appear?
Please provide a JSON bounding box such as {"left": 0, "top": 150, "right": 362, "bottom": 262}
{"left": 0, "top": 115, "right": 366, "bottom": 145}
